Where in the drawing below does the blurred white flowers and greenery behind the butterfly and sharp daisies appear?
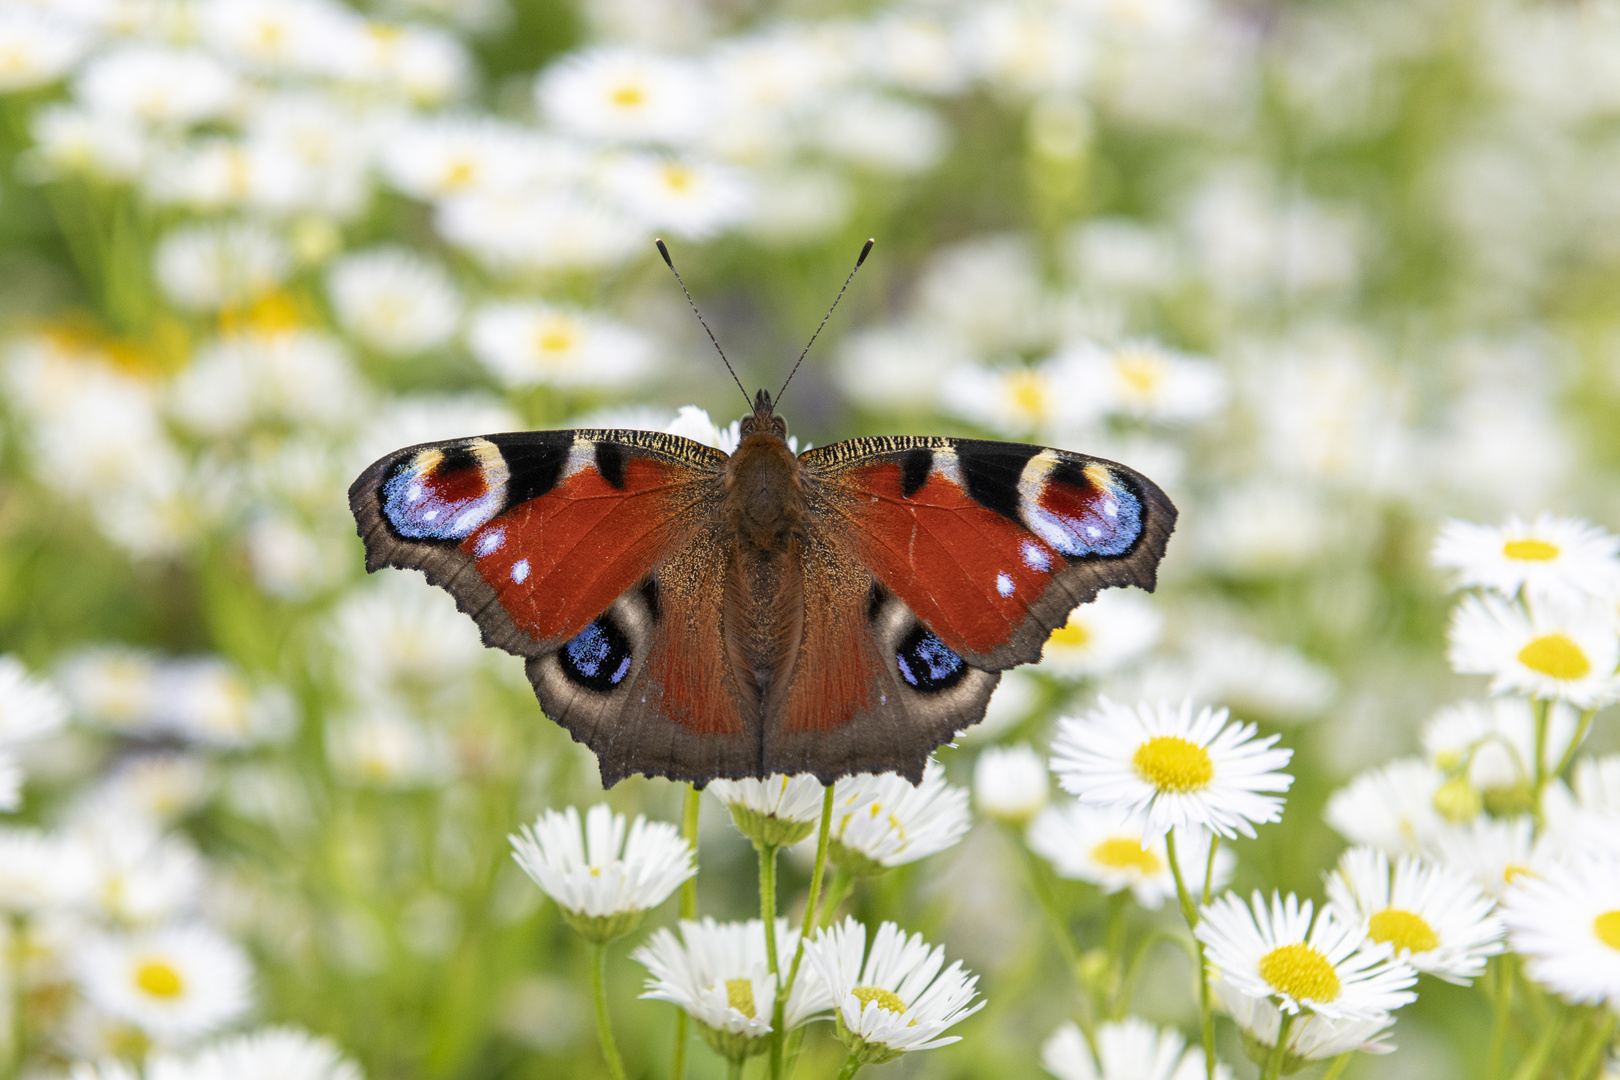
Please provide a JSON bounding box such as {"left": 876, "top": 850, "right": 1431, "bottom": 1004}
{"left": 0, "top": 0, "right": 1620, "bottom": 1080}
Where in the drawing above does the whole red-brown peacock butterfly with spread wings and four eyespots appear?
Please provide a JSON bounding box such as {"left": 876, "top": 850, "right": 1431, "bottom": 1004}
{"left": 348, "top": 241, "right": 1176, "bottom": 787}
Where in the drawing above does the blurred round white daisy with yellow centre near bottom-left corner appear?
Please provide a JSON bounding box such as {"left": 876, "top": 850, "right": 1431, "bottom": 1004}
{"left": 76, "top": 925, "right": 253, "bottom": 1041}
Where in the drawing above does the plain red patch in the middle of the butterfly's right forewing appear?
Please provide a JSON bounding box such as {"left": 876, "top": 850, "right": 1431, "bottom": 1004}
{"left": 847, "top": 461, "right": 1066, "bottom": 654}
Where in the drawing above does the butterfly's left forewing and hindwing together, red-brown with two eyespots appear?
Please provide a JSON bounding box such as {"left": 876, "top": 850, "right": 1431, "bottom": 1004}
{"left": 350, "top": 429, "right": 760, "bottom": 784}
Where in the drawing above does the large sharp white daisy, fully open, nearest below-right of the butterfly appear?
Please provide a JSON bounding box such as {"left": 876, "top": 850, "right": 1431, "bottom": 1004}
{"left": 1051, "top": 698, "right": 1294, "bottom": 839}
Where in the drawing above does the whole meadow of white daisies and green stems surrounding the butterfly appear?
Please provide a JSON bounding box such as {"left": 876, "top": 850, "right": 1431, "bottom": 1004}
{"left": 0, "top": 0, "right": 1620, "bottom": 1080}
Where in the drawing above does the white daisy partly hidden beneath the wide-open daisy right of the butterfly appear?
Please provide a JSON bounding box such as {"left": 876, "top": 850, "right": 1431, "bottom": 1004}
{"left": 1027, "top": 801, "right": 1238, "bottom": 912}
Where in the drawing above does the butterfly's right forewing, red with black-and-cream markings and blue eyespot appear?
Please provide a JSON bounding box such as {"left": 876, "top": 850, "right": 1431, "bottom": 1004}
{"left": 800, "top": 437, "right": 1176, "bottom": 670}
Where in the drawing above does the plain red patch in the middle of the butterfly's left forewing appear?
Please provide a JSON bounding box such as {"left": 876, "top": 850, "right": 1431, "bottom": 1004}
{"left": 460, "top": 457, "right": 680, "bottom": 641}
